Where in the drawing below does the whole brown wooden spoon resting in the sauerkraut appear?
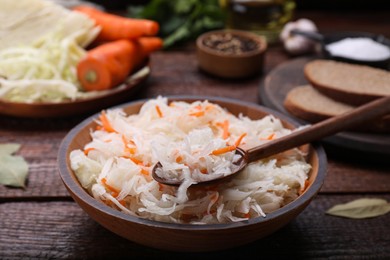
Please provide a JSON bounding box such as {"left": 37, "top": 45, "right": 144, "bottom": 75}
{"left": 152, "top": 96, "right": 390, "bottom": 186}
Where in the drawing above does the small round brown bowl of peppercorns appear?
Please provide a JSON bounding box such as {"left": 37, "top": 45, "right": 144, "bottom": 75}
{"left": 196, "top": 30, "right": 267, "bottom": 79}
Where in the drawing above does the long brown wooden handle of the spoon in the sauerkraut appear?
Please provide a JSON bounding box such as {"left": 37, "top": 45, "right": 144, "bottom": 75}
{"left": 247, "top": 96, "right": 390, "bottom": 162}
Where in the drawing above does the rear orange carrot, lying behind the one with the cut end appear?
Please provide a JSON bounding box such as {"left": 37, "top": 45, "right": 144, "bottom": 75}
{"left": 73, "top": 5, "right": 160, "bottom": 41}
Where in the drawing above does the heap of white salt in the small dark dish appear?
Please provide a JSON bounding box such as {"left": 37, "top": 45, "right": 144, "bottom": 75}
{"left": 326, "top": 38, "right": 390, "bottom": 61}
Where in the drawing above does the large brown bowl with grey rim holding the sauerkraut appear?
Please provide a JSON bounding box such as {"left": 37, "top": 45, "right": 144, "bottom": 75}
{"left": 58, "top": 96, "right": 327, "bottom": 252}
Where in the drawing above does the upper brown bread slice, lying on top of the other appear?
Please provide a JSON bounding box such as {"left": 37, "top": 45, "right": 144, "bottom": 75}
{"left": 304, "top": 60, "right": 390, "bottom": 105}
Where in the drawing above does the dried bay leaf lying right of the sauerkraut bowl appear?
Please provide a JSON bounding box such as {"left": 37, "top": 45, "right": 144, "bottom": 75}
{"left": 326, "top": 198, "right": 390, "bottom": 219}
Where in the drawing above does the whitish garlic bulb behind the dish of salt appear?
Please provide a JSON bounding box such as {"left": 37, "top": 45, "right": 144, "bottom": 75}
{"left": 280, "top": 18, "right": 317, "bottom": 55}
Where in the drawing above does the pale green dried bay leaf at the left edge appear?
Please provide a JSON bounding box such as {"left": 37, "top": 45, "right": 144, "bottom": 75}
{"left": 0, "top": 143, "right": 28, "bottom": 187}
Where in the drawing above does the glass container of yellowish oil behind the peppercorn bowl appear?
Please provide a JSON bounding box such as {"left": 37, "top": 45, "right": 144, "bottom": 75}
{"left": 221, "top": 0, "right": 295, "bottom": 44}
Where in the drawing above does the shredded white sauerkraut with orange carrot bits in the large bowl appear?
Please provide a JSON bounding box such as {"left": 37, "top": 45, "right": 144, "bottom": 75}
{"left": 70, "top": 97, "right": 311, "bottom": 224}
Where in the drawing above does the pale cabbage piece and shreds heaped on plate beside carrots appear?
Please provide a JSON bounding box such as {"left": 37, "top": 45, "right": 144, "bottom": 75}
{"left": 0, "top": 0, "right": 100, "bottom": 103}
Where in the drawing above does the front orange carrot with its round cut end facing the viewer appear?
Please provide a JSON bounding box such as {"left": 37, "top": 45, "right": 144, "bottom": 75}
{"left": 77, "top": 37, "right": 162, "bottom": 91}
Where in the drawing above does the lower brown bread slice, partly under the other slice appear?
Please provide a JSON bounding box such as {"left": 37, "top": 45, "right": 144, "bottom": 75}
{"left": 284, "top": 85, "right": 390, "bottom": 133}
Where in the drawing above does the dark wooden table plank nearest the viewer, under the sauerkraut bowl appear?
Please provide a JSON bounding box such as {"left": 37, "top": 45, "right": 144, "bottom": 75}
{"left": 0, "top": 194, "right": 390, "bottom": 259}
